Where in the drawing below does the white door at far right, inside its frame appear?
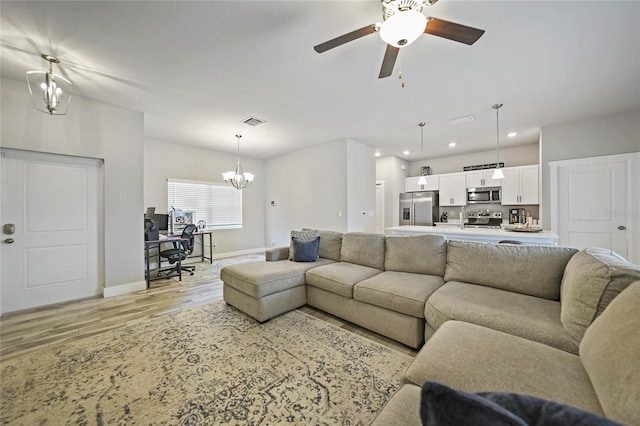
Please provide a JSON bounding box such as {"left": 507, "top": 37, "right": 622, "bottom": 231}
{"left": 550, "top": 156, "right": 631, "bottom": 257}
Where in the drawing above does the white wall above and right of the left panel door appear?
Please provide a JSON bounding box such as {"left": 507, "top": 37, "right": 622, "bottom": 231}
{"left": 0, "top": 78, "right": 144, "bottom": 287}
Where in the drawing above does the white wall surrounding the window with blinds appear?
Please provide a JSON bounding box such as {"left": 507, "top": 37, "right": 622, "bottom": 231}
{"left": 144, "top": 139, "right": 266, "bottom": 257}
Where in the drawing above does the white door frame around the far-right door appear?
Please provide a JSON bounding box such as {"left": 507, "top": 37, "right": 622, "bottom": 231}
{"left": 549, "top": 152, "right": 640, "bottom": 263}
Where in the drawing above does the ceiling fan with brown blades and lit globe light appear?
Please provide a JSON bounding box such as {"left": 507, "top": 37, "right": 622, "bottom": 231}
{"left": 313, "top": 0, "right": 484, "bottom": 78}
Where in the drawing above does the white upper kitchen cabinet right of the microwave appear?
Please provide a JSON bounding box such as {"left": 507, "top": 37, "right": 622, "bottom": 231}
{"left": 502, "top": 164, "right": 539, "bottom": 206}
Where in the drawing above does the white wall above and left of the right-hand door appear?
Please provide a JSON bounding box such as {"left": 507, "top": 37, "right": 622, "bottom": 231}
{"left": 540, "top": 109, "right": 640, "bottom": 230}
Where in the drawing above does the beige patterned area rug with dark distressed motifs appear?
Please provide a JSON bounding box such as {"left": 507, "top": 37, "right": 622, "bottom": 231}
{"left": 0, "top": 302, "right": 412, "bottom": 425}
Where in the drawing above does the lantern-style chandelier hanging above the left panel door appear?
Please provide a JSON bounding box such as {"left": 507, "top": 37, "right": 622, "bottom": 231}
{"left": 27, "top": 54, "right": 73, "bottom": 115}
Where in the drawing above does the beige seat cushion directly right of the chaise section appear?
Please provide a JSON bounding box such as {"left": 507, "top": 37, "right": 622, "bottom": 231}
{"left": 305, "top": 262, "right": 380, "bottom": 299}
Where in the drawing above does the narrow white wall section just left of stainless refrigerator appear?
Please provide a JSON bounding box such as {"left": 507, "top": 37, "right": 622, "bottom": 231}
{"left": 376, "top": 156, "right": 408, "bottom": 228}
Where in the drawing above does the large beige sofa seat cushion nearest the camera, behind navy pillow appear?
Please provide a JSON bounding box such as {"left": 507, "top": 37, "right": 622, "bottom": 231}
{"left": 404, "top": 321, "right": 604, "bottom": 416}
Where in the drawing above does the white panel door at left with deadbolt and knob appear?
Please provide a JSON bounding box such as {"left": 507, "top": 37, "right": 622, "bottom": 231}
{"left": 0, "top": 149, "right": 104, "bottom": 313}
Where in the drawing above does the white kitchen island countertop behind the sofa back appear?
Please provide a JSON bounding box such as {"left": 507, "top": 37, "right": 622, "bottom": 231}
{"left": 385, "top": 225, "right": 558, "bottom": 246}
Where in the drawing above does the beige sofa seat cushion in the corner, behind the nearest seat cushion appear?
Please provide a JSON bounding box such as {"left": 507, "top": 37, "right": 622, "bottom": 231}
{"left": 424, "top": 281, "right": 578, "bottom": 353}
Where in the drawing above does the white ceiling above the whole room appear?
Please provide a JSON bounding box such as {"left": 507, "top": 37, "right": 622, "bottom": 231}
{"left": 0, "top": 0, "right": 640, "bottom": 160}
